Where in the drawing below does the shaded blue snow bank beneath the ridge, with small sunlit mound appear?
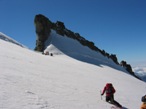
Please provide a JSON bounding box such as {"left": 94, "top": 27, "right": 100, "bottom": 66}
{"left": 44, "top": 30, "right": 126, "bottom": 72}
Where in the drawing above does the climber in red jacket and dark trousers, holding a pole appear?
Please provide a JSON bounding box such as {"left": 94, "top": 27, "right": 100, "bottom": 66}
{"left": 101, "top": 83, "right": 122, "bottom": 108}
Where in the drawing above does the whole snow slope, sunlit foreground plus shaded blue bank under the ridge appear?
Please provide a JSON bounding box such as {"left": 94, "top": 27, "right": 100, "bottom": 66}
{"left": 0, "top": 31, "right": 146, "bottom": 109}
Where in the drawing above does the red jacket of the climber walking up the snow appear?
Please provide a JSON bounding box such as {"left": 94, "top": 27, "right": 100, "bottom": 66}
{"left": 102, "top": 83, "right": 116, "bottom": 96}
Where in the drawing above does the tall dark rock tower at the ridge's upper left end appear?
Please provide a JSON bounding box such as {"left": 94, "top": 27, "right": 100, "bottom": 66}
{"left": 34, "top": 14, "right": 52, "bottom": 51}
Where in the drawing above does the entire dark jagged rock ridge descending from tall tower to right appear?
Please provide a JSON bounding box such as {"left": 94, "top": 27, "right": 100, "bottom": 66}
{"left": 34, "top": 14, "right": 139, "bottom": 79}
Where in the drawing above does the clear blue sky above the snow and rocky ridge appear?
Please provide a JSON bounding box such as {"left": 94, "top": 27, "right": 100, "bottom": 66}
{"left": 0, "top": 0, "right": 146, "bottom": 66}
